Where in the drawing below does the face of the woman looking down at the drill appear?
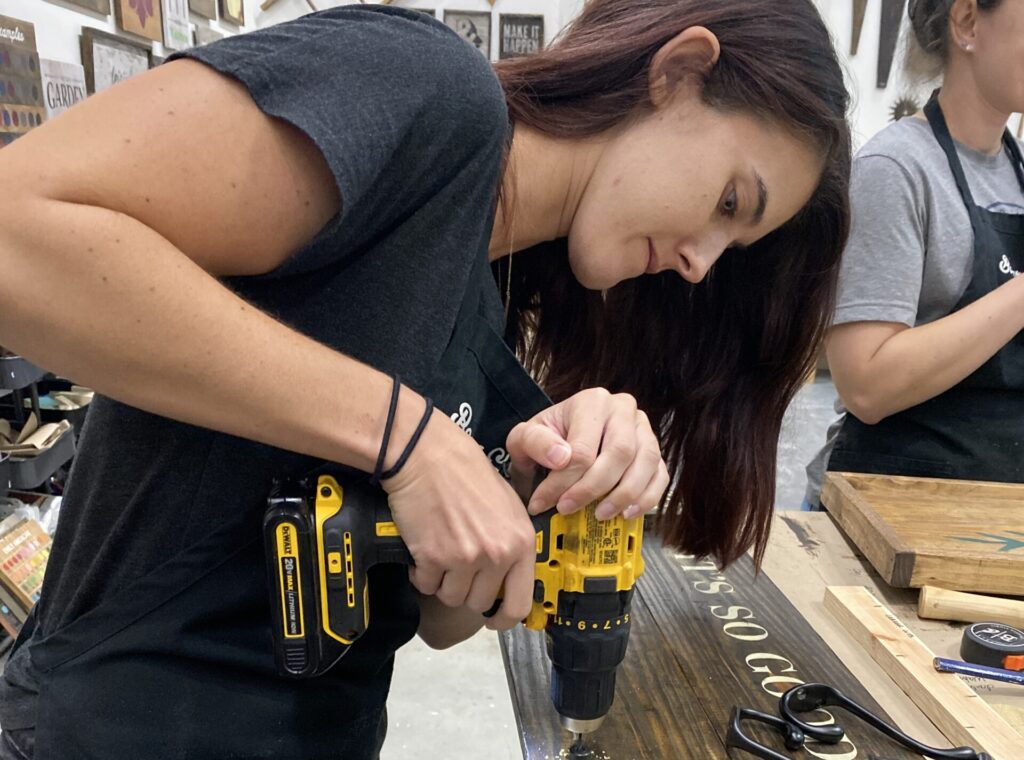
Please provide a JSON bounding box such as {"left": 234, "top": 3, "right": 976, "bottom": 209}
{"left": 568, "top": 96, "right": 821, "bottom": 290}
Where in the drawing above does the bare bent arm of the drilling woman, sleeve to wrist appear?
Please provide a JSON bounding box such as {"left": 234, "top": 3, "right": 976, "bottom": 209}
{"left": 0, "top": 61, "right": 422, "bottom": 469}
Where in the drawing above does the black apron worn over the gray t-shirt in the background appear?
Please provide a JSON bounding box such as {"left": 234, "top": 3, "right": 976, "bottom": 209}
{"left": 828, "top": 92, "right": 1024, "bottom": 482}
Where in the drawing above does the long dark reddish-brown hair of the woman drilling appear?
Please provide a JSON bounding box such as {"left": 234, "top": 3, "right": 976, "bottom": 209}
{"left": 496, "top": 0, "right": 850, "bottom": 564}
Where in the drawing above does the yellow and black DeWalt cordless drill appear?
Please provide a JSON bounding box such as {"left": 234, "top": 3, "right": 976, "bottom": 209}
{"left": 263, "top": 475, "right": 643, "bottom": 740}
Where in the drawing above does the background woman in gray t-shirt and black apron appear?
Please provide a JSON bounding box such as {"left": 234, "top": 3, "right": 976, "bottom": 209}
{"left": 807, "top": 0, "right": 1024, "bottom": 512}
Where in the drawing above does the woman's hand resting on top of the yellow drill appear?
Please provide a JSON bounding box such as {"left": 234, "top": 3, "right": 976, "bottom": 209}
{"left": 506, "top": 388, "right": 669, "bottom": 519}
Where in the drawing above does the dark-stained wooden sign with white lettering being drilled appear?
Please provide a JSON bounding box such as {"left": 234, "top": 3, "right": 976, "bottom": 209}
{"left": 501, "top": 536, "right": 920, "bottom": 760}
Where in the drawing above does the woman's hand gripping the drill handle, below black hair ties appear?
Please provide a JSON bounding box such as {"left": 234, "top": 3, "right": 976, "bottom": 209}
{"left": 381, "top": 411, "right": 537, "bottom": 630}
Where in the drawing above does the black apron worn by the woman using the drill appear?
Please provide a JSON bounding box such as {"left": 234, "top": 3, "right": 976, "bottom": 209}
{"left": 0, "top": 251, "right": 550, "bottom": 760}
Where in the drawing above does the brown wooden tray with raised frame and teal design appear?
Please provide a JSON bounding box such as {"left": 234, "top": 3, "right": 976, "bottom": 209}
{"left": 821, "top": 472, "right": 1024, "bottom": 595}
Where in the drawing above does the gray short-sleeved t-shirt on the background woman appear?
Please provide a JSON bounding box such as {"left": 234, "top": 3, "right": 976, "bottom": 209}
{"left": 806, "top": 117, "right": 1024, "bottom": 504}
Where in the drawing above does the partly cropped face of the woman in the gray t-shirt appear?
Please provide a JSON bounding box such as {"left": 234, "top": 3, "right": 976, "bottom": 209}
{"left": 968, "top": 0, "right": 1024, "bottom": 114}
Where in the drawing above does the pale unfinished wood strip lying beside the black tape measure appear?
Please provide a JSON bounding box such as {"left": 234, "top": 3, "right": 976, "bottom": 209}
{"left": 825, "top": 586, "right": 1024, "bottom": 760}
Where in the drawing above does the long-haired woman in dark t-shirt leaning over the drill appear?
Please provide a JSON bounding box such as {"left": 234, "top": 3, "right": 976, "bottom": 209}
{"left": 0, "top": 0, "right": 849, "bottom": 760}
